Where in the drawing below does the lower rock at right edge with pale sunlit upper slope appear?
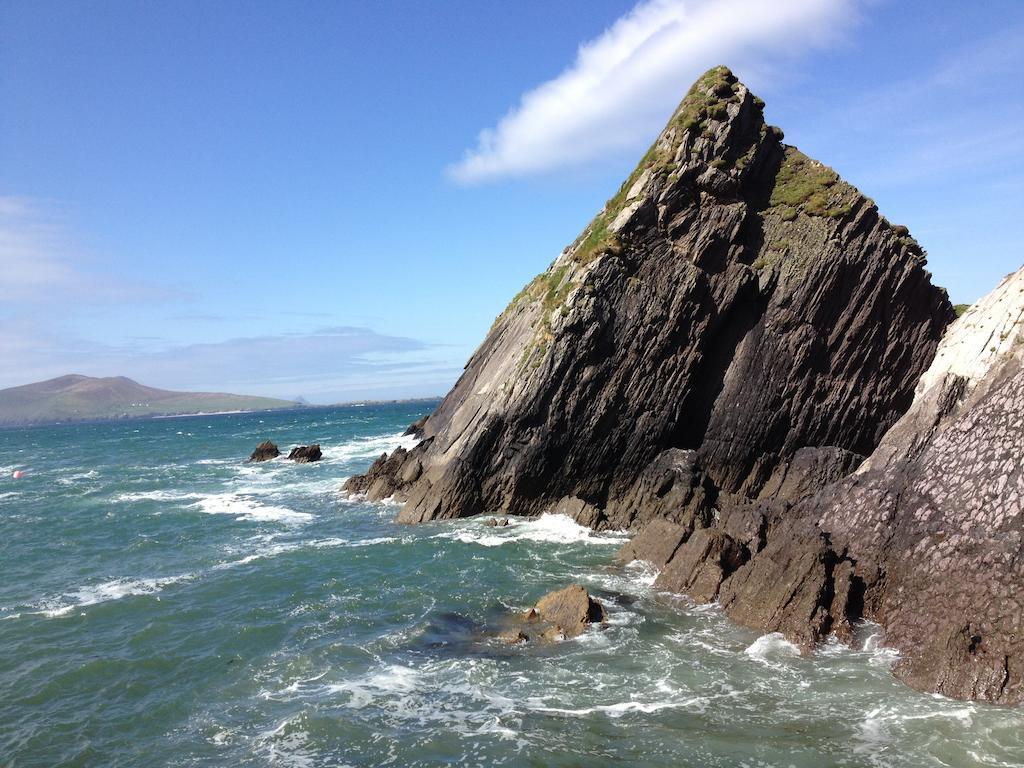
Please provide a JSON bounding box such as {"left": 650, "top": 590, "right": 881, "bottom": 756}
{"left": 621, "top": 268, "right": 1024, "bottom": 703}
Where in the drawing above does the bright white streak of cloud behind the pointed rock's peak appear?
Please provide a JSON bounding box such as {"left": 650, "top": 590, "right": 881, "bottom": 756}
{"left": 447, "top": 0, "right": 855, "bottom": 183}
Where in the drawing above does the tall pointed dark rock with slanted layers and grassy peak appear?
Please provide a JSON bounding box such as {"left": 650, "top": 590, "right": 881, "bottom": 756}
{"left": 346, "top": 68, "right": 953, "bottom": 528}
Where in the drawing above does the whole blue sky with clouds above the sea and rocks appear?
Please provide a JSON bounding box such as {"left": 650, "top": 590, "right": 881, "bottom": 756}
{"left": 0, "top": 0, "right": 1024, "bottom": 402}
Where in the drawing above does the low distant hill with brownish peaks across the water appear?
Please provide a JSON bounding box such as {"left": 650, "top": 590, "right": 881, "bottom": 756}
{"left": 0, "top": 374, "right": 298, "bottom": 425}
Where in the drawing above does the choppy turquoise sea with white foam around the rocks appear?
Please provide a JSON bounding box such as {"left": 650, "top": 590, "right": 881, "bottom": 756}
{"left": 0, "top": 403, "right": 1024, "bottom": 768}
